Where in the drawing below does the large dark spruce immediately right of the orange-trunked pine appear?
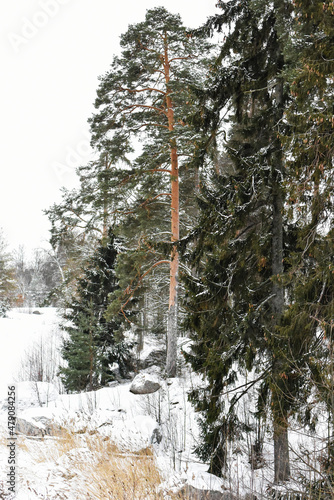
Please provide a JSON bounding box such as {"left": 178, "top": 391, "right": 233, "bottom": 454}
{"left": 185, "top": 1, "right": 297, "bottom": 482}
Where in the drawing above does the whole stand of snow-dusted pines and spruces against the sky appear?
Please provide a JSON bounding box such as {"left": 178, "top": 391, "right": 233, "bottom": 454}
{"left": 0, "top": 0, "right": 334, "bottom": 500}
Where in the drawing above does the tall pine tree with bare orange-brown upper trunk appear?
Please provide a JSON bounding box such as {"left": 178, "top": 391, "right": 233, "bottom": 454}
{"left": 91, "top": 7, "right": 213, "bottom": 376}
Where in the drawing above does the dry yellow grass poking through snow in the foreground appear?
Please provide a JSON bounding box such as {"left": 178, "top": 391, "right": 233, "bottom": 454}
{"left": 21, "top": 431, "right": 188, "bottom": 500}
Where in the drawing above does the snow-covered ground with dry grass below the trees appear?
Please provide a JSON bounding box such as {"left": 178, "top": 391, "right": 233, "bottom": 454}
{"left": 0, "top": 308, "right": 326, "bottom": 500}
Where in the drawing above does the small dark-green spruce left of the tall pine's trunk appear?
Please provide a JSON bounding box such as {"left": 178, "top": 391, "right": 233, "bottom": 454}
{"left": 60, "top": 229, "right": 131, "bottom": 391}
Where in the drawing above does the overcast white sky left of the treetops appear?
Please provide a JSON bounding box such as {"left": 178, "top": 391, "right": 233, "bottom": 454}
{"left": 0, "top": 0, "right": 217, "bottom": 256}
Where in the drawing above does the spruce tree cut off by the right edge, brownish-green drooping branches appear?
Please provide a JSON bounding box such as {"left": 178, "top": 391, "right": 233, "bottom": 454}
{"left": 281, "top": 1, "right": 334, "bottom": 492}
